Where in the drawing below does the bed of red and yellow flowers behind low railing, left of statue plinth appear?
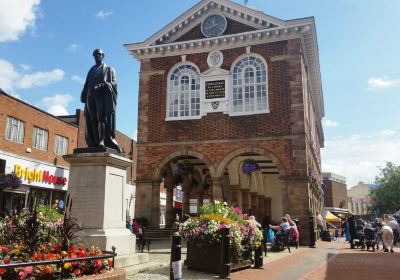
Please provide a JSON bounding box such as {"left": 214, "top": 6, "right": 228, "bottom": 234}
{"left": 0, "top": 205, "right": 117, "bottom": 280}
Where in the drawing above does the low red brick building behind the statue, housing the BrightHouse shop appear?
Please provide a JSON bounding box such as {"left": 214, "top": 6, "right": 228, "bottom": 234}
{"left": 0, "top": 89, "right": 136, "bottom": 219}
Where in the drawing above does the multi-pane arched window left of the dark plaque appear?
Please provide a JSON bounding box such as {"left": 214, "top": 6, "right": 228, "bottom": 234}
{"left": 167, "top": 63, "right": 200, "bottom": 119}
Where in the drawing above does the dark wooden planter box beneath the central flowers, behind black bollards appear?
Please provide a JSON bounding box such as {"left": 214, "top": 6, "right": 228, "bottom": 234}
{"left": 185, "top": 242, "right": 251, "bottom": 273}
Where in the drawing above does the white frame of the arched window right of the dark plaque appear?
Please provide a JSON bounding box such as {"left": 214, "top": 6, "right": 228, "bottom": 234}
{"left": 229, "top": 53, "right": 270, "bottom": 116}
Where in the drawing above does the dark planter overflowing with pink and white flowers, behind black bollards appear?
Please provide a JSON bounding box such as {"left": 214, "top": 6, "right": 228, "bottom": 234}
{"left": 179, "top": 202, "right": 263, "bottom": 272}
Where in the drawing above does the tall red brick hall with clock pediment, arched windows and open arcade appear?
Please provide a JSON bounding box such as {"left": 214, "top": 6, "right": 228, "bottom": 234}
{"left": 125, "top": 0, "right": 324, "bottom": 244}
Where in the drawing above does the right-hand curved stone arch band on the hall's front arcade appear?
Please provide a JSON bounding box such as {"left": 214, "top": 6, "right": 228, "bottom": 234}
{"left": 215, "top": 146, "right": 287, "bottom": 178}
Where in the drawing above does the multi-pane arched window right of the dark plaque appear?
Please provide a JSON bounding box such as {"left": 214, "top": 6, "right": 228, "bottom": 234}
{"left": 231, "top": 54, "right": 268, "bottom": 115}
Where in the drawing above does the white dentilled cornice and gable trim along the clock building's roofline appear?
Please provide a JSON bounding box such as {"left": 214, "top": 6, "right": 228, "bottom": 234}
{"left": 124, "top": 0, "right": 325, "bottom": 119}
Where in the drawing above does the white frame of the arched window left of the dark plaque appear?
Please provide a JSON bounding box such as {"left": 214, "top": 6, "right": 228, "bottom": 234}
{"left": 165, "top": 61, "right": 202, "bottom": 121}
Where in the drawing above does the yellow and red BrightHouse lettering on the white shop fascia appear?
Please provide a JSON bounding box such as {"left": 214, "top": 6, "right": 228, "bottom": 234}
{"left": 14, "top": 164, "right": 67, "bottom": 186}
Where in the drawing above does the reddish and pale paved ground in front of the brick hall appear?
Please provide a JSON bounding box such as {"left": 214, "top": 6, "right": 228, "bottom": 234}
{"left": 128, "top": 239, "right": 400, "bottom": 280}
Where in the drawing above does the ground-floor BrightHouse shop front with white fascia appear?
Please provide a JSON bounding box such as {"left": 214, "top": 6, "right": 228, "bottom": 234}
{"left": 0, "top": 151, "right": 69, "bottom": 217}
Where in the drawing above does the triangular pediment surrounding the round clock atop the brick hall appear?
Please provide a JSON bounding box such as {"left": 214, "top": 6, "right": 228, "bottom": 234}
{"left": 130, "top": 0, "right": 285, "bottom": 47}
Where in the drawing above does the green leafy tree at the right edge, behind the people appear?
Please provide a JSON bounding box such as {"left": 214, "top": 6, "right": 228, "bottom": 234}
{"left": 370, "top": 162, "right": 400, "bottom": 214}
